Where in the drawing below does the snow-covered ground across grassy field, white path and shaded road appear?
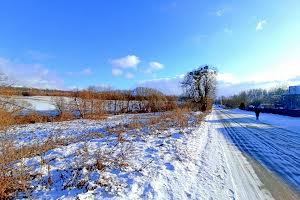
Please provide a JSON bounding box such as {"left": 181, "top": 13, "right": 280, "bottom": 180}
{"left": 2, "top": 109, "right": 300, "bottom": 199}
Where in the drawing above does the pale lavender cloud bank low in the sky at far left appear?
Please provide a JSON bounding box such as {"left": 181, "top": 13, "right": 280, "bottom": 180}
{"left": 0, "top": 57, "right": 63, "bottom": 89}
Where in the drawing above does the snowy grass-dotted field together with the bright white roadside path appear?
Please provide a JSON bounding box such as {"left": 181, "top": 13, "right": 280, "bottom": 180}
{"left": 2, "top": 112, "right": 286, "bottom": 199}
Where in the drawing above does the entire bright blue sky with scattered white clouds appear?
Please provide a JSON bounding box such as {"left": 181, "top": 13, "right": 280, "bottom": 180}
{"left": 0, "top": 0, "right": 300, "bottom": 95}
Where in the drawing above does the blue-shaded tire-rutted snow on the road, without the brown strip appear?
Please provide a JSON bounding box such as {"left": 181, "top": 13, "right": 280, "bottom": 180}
{"left": 217, "top": 111, "right": 300, "bottom": 192}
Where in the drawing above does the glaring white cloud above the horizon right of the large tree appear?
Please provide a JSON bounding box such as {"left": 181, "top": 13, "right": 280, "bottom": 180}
{"left": 218, "top": 50, "right": 300, "bottom": 95}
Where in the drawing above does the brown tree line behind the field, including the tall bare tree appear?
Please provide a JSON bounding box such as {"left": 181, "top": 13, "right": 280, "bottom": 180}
{"left": 0, "top": 65, "right": 217, "bottom": 125}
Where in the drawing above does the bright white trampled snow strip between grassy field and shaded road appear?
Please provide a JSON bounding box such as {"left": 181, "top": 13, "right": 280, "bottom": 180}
{"left": 146, "top": 113, "right": 273, "bottom": 199}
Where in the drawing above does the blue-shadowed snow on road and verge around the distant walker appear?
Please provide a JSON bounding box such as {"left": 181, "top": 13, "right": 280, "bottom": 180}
{"left": 219, "top": 110, "right": 300, "bottom": 195}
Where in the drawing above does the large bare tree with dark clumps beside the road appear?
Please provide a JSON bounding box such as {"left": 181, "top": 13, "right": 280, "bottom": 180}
{"left": 181, "top": 65, "right": 217, "bottom": 111}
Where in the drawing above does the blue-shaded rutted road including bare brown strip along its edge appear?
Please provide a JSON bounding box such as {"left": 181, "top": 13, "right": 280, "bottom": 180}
{"left": 213, "top": 109, "right": 300, "bottom": 199}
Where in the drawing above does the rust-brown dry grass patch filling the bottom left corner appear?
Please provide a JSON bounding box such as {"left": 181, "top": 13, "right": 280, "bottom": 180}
{"left": 0, "top": 135, "right": 73, "bottom": 199}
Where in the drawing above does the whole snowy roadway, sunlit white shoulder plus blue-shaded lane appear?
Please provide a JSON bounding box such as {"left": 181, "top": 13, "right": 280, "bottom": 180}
{"left": 150, "top": 109, "right": 300, "bottom": 200}
